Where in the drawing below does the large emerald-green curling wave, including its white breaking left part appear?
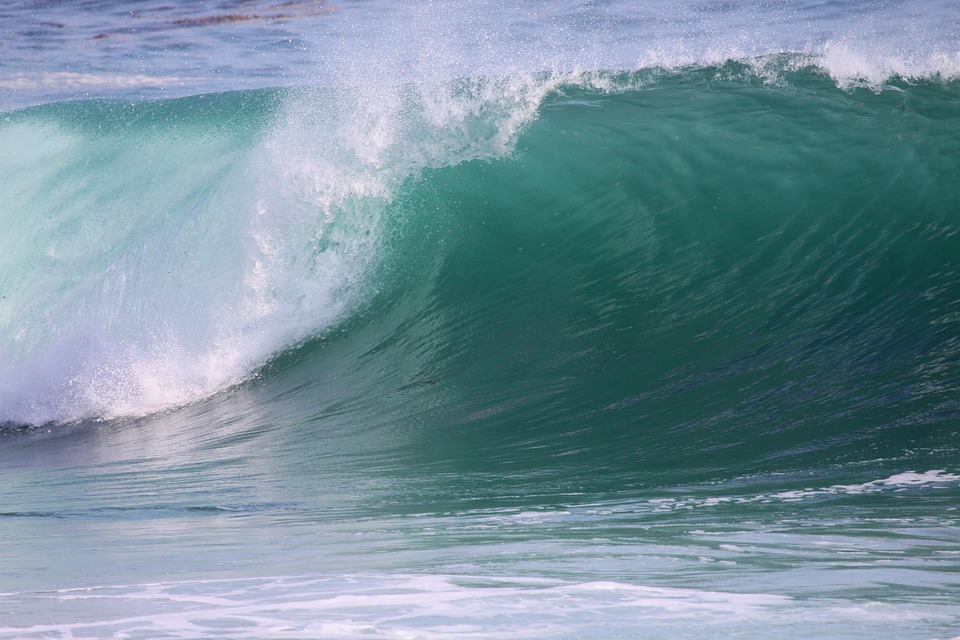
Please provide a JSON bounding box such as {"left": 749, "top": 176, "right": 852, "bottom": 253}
{"left": 0, "top": 65, "right": 958, "bottom": 432}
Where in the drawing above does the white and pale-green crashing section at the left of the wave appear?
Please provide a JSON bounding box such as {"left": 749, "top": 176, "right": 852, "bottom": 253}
{"left": 2, "top": 70, "right": 584, "bottom": 423}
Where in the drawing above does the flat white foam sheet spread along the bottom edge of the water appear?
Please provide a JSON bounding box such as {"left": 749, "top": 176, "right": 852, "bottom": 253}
{"left": 0, "top": 574, "right": 958, "bottom": 639}
